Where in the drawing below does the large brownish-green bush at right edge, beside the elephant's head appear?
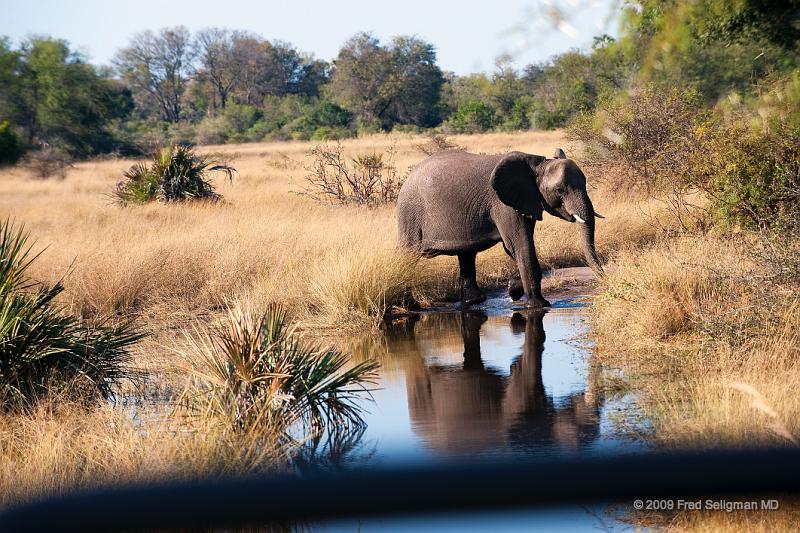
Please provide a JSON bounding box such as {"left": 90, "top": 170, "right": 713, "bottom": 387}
{"left": 567, "top": 81, "right": 800, "bottom": 227}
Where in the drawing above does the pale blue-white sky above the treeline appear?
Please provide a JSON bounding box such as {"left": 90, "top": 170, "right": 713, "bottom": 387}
{"left": 0, "top": 0, "right": 619, "bottom": 75}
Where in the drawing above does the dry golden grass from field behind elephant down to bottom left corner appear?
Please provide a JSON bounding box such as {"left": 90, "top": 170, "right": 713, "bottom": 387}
{"left": 0, "top": 132, "right": 659, "bottom": 510}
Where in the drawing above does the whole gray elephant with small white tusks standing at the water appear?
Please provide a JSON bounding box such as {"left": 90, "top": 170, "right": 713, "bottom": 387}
{"left": 397, "top": 149, "right": 602, "bottom": 307}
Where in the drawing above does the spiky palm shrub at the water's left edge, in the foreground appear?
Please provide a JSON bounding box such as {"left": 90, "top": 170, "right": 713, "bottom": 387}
{"left": 184, "top": 304, "right": 378, "bottom": 440}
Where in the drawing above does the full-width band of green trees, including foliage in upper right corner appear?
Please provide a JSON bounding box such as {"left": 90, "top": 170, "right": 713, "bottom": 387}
{"left": 0, "top": 0, "right": 800, "bottom": 166}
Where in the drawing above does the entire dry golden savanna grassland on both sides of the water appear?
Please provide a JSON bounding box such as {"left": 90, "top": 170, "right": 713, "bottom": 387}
{"left": 0, "top": 132, "right": 800, "bottom": 530}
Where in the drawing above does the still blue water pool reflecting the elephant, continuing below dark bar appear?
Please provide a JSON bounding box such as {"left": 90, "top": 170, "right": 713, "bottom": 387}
{"left": 304, "top": 294, "right": 641, "bottom": 531}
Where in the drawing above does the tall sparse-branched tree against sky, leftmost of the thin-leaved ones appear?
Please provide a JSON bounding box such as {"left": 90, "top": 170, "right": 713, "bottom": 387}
{"left": 114, "top": 26, "right": 195, "bottom": 122}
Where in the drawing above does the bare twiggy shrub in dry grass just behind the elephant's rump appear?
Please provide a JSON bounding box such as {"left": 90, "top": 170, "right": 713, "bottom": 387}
{"left": 301, "top": 144, "right": 402, "bottom": 206}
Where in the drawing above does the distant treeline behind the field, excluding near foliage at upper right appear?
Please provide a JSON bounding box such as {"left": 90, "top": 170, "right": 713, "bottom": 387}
{"left": 0, "top": 27, "right": 629, "bottom": 162}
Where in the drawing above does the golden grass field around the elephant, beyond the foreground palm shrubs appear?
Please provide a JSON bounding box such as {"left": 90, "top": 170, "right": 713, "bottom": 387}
{"left": 0, "top": 132, "right": 657, "bottom": 326}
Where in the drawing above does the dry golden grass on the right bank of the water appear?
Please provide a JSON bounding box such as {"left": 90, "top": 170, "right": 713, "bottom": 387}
{"left": 592, "top": 235, "right": 800, "bottom": 531}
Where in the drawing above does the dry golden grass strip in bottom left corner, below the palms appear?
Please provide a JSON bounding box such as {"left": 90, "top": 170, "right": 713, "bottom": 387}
{"left": 0, "top": 399, "right": 283, "bottom": 509}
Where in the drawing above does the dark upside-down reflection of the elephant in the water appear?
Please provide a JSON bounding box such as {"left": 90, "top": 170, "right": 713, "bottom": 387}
{"left": 406, "top": 311, "right": 599, "bottom": 453}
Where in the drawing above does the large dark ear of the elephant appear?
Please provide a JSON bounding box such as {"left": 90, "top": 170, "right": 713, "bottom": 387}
{"left": 490, "top": 152, "right": 544, "bottom": 220}
